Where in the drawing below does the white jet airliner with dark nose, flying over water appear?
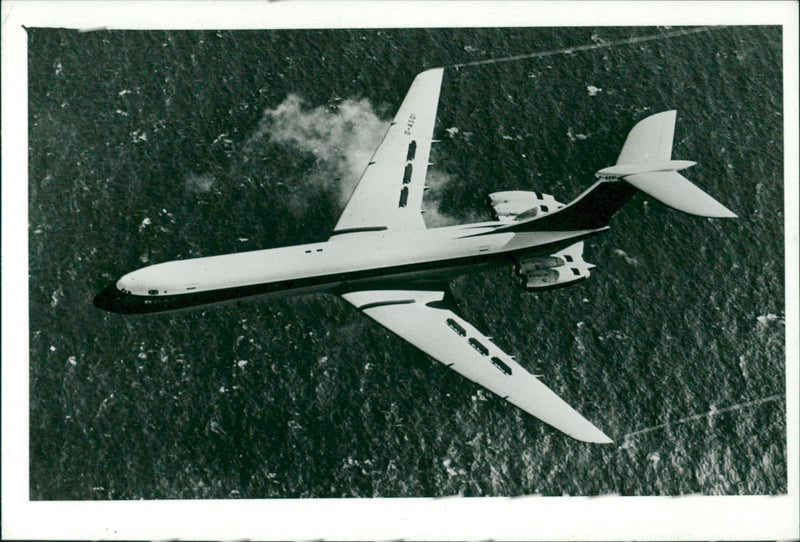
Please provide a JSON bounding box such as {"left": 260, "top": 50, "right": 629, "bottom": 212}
{"left": 94, "top": 68, "right": 736, "bottom": 443}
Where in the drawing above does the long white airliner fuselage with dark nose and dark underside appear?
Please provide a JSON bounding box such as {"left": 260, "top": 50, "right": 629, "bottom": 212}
{"left": 95, "top": 222, "right": 595, "bottom": 313}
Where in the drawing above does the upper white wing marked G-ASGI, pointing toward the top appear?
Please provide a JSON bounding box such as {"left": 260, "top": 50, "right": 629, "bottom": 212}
{"left": 333, "top": 68, "right": 444, "bottom": 238}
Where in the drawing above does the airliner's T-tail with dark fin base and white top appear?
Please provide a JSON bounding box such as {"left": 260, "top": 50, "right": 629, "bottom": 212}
{"left": 498, "top": 111, "right": 736, "bottom": 231}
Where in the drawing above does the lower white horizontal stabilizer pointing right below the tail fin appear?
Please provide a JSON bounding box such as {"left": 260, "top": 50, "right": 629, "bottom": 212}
{"left": 623, "top": 171, "right": 736, "bottom": 218}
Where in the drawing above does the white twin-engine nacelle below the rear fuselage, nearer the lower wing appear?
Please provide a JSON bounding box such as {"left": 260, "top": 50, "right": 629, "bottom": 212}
{"left": 514, "top": 241, "right": 595, "bottom": 290}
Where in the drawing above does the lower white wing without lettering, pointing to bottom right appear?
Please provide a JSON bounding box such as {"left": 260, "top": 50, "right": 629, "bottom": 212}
{"left": 342, "top": 290, "right": 611, "bottom": 444}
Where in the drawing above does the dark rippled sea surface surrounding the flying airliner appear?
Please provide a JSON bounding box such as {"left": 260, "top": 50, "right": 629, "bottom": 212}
{"left": 28, "top": 27, "right": 787, "bottom": 499}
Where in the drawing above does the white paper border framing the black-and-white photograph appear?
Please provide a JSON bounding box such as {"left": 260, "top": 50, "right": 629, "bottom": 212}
{"left": 2, "top": 1, "right": 800, "bottom": 540}
